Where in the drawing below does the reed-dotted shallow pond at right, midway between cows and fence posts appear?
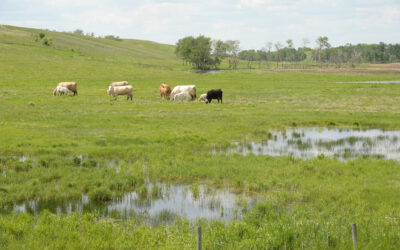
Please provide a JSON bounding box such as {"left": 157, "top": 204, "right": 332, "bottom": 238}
{"left": 213, "top": 128, "right": 400, "bottom": 161}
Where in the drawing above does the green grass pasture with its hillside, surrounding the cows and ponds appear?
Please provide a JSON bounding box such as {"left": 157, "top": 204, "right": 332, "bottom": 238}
{"left": 0, "top": 26, "right": 400, "bottom": 249}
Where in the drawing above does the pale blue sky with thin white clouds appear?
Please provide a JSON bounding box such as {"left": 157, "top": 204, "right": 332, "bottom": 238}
{"left": 0, "top": 0, "right": 400, "bottom": 49}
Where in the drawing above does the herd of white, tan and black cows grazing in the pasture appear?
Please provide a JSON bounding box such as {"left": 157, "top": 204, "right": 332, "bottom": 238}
{"left": 53, "top": 81, "right": 222, "bottom": 104}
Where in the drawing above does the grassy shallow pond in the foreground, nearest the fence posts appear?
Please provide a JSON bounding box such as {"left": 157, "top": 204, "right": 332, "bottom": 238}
{"left": 1, "top": 183, "right": 256, "bottom": 225}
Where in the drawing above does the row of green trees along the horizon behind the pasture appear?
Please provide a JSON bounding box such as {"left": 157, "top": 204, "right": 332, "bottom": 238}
{"left": 175, "top": 36, "right": 400, "bottom": 70}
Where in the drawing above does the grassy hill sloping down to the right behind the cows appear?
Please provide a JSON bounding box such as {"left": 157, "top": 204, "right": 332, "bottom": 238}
{"left": 0, "top": 25, "right": 180, "bottom": 84}
